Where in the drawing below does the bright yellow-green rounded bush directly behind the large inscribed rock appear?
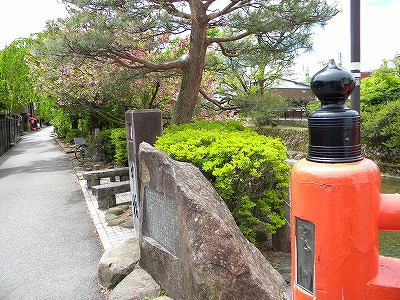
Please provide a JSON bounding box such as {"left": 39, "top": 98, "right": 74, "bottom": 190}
{"left": 155, "top": 121, "right": 289, "bottom": 243}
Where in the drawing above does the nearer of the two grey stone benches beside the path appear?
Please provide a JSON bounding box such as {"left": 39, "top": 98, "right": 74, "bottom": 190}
{"left": 92, "top": 181, "right": 131, "bottom": 209}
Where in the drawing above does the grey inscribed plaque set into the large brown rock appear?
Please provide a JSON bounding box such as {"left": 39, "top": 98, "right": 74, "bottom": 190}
{"left": 142, "top": 186, "right": 179, "bottom": 256}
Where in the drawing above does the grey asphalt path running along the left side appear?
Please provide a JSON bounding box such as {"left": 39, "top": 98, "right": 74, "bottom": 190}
{"left": 0, "top": 127, "right": 102, "bottom": 300}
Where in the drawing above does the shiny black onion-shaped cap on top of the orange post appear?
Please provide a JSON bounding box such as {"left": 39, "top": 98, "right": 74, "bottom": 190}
{"left": 307, "top": 59, "right": 363, "bottom": 163}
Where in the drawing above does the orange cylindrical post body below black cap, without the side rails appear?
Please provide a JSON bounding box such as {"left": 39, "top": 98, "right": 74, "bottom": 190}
{"left": 291, "top": 159, "right": 380, "bottom": 300}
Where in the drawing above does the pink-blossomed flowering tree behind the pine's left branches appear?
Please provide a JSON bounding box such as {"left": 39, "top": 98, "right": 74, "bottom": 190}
{"left": 30, "top": 28, "right": 189, "bottom": 125}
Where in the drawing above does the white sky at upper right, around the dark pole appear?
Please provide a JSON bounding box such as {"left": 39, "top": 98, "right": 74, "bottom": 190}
{"left": 293, "top": 0, "right": 400, "bottom": 80}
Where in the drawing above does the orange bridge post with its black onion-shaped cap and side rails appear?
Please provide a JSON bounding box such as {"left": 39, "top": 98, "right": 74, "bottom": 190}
{"left": 290, "top": 61, "right": 400, "bottom": 300}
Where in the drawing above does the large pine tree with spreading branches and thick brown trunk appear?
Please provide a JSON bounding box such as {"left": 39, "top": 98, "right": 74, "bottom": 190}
{"left": 47, "top": 0, "right": 338, "bottom": 124}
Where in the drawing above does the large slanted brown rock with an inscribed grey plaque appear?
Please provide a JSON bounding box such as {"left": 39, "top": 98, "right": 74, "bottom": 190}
{"left": 139, "top": 143, "right": 287, "bottom": 300}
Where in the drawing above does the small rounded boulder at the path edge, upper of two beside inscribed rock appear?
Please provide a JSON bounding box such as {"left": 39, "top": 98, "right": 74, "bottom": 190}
{"left": 98, "top": 238, "right": 140, "bottom": 288}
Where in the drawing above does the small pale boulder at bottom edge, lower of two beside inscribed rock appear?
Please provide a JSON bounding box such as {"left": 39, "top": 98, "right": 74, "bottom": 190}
{"left": 108, "top": 268, "right": 161, "bottom": 300}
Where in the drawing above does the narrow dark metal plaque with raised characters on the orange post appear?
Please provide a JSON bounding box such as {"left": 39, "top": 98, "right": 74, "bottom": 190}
{"left": 296, "top": 217, "right": 315, "bottom": 294}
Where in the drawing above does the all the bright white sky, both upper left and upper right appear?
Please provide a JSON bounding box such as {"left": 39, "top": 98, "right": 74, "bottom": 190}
{"left": 0, "top": 0, "right": 400, "bottom": 80}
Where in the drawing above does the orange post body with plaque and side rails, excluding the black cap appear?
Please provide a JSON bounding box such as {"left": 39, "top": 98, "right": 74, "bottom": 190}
{"left": 291, "top": 159, "right": 400, "bottom": 300}
